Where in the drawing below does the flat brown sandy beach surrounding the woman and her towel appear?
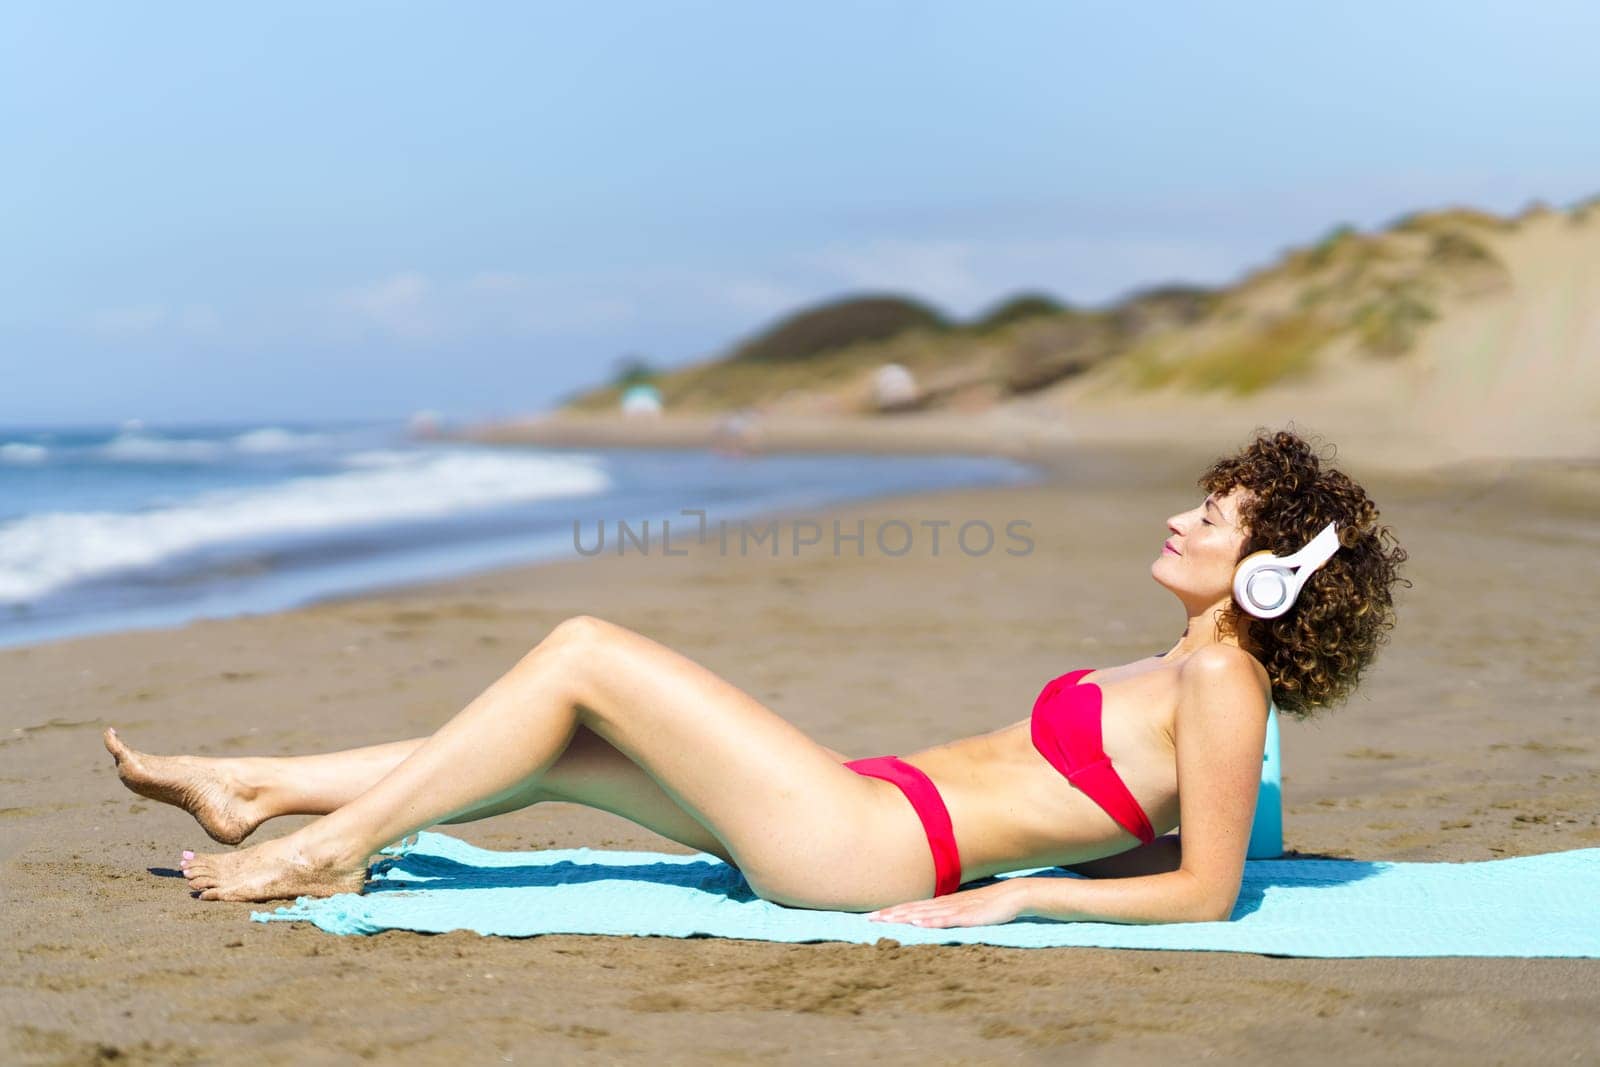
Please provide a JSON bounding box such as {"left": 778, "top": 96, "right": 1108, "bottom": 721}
{"left": 0, "top": 424, "right": 1600, "bottom": 1064}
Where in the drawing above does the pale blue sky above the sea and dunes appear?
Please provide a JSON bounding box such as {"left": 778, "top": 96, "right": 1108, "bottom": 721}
{"left": 0, "top": 0, "right": 1600, "bottom": 424}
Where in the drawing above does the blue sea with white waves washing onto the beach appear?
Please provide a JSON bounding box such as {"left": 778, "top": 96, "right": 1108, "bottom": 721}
{"left": 0, "top": 421, "right": 1035, "bottom": 646}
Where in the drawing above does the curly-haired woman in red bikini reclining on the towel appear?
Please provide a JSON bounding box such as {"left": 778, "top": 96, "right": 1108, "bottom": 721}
{"left": 106, "top": 432, "right": 1406, "bottom": 926}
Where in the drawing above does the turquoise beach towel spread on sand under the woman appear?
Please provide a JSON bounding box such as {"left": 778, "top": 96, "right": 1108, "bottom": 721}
{"left": 250, "top": 832, "right": 1600, "bottom": 957}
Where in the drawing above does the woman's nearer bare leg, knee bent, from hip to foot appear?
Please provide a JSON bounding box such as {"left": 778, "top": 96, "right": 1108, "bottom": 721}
{"left": 186, "top": 616, "right": 902, "bottom": 905}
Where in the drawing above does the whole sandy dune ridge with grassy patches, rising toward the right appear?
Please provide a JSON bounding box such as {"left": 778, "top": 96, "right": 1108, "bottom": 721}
{"left": 544, "top": 205, "right": 1600, "bottom": 469}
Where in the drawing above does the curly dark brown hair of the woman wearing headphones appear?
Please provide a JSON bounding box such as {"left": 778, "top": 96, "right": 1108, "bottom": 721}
{"left": 1200, "top": 427, "right": 1411, "bottom": 720}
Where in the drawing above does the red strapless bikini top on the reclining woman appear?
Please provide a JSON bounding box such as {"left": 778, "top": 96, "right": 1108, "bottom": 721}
{"left": 1030, "top": 667, "right": 1155, "bottom": 845}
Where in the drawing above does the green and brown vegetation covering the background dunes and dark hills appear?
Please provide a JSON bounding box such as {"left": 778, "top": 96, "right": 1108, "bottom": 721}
{"left": 568, "top": 200, "right": 1548, "bottom": 413}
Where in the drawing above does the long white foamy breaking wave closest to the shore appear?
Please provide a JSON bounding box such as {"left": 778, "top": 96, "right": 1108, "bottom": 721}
{"left": 0, "top": 451, "right": 611, "bottom": 603}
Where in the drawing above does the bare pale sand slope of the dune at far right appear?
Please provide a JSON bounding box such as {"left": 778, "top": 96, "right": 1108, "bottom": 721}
{"left": 1043, "top": 211, "right": 1600, "bottom": 466}
